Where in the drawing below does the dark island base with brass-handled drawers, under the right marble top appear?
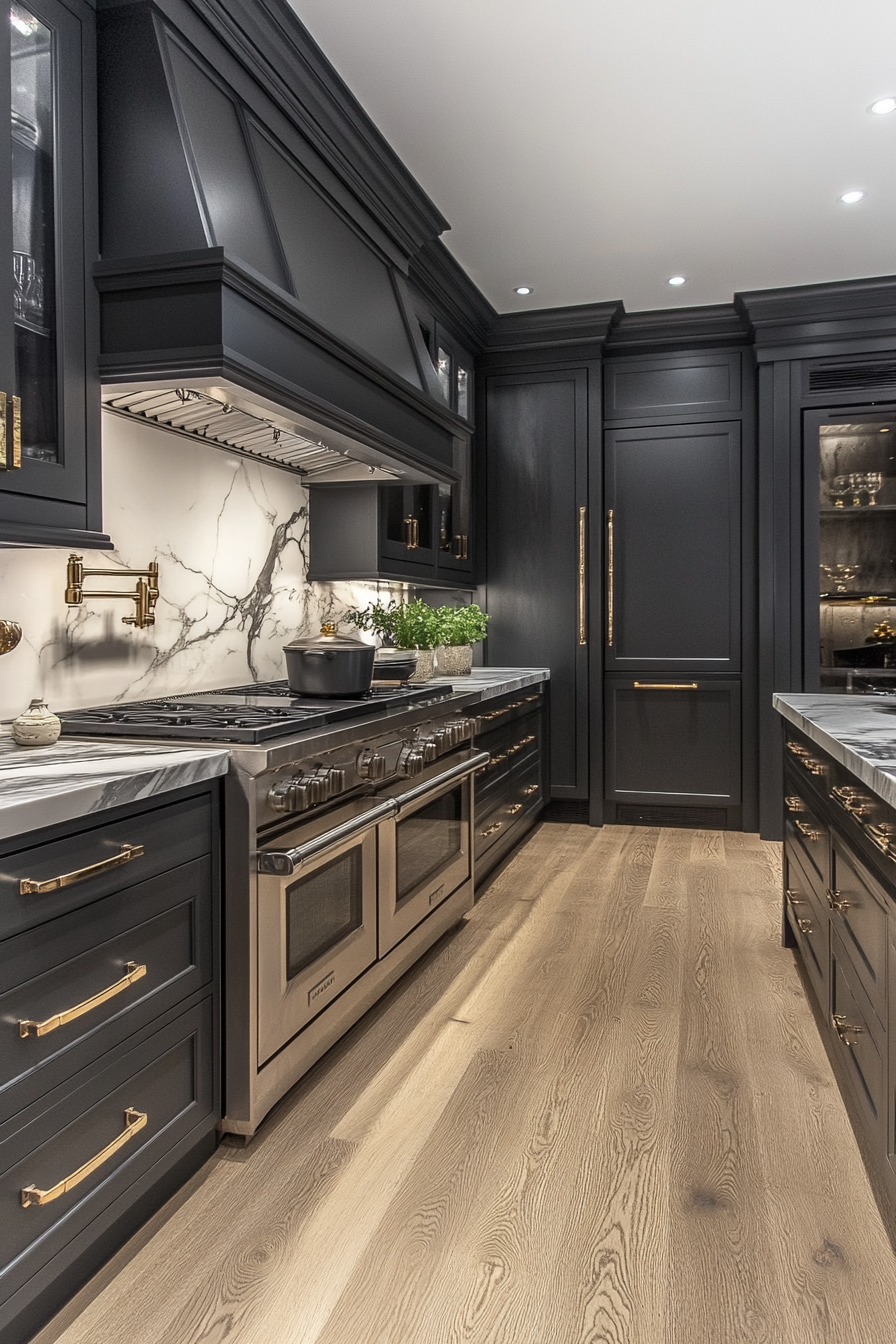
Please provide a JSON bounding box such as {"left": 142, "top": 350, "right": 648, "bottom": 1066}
{"left": 783, "top": 726, "right": 896, "bottom": 1218}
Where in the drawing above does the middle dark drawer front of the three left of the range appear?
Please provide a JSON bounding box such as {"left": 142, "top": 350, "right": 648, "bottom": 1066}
{"left": 0, "top": 859, "right": 212, "bottom": 1122}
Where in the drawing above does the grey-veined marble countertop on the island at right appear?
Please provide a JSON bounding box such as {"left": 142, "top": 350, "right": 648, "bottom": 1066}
{"left": 774, "top": 694, "right": 896, "bottom": 808}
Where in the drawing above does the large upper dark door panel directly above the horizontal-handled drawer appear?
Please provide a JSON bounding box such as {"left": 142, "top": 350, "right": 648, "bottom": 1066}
{"left": 606, "top": 423, "right": 740, "bottom": 672}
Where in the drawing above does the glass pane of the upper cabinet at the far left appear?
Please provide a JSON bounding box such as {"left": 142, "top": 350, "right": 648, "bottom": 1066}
{"left": 9, "top": 4, "right": 60, "bottom": 462}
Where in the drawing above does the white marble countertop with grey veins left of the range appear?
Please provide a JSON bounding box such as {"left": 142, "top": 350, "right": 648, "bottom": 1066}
{"left": 0, "top": 737, "right": 230, "bottom": 840}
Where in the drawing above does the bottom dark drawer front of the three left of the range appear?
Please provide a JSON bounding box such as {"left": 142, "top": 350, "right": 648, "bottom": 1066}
{"left": 0, "top": 1000, "right": 214, "bottom": 1297}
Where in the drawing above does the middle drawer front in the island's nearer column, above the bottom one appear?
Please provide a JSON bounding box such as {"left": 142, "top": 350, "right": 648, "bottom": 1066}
{"left": 829, "top": 836, "right": 888, "bottom": 1021}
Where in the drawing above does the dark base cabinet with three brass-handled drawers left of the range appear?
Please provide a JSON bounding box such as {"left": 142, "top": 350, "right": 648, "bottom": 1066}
{"left": 0, "top": 784, "right": 220, "bottom": 1344}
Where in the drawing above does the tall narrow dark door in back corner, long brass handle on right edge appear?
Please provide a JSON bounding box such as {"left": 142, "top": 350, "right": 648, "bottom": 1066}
{"left": 486, "top": 370, "right": 588, "bottom": 798}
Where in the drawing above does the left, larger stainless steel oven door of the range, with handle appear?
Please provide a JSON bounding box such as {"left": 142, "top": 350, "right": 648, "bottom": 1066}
{"left": 252, "top": 798, "right": 395, "bottom": 1066}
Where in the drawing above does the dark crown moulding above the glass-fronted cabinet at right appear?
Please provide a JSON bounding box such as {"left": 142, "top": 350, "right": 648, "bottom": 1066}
{"left": 735, "top": 276, "right": 896, "bottom": 359}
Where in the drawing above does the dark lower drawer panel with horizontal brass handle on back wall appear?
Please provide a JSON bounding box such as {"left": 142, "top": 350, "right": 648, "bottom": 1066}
{"left": 606, "top": 677, "right": 740, "bottom": 808}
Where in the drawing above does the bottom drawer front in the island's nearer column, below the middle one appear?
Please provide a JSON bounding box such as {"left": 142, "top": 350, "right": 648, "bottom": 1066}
{"left": 830, "top": 931, "right": 887, "bottom": 1152}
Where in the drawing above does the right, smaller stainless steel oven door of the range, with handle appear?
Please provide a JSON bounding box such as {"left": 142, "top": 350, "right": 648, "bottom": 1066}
{"left": 379, "top": 751, "right": 489, "bottom": 957}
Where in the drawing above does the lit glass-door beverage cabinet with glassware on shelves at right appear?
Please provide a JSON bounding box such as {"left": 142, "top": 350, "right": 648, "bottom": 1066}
{"left": 807, "top": 407, "right": 896, "bottom": 694}
